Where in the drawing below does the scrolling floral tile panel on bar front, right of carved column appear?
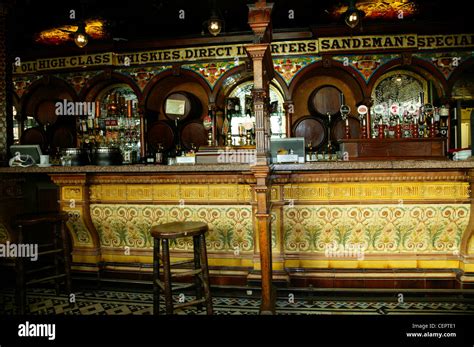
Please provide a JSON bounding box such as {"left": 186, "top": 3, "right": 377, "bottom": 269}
{"left": 284, "top": 204, "right": 470, "bottom": 253}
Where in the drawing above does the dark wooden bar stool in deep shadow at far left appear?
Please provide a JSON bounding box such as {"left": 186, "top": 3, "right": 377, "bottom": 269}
{"left": 13, "top": 212, "right": 71, "bottom": 314}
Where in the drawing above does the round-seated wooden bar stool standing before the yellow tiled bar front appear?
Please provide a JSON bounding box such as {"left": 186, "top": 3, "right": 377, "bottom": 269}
{"left": 150, "top": 222, "right": 213, "bottom": 314}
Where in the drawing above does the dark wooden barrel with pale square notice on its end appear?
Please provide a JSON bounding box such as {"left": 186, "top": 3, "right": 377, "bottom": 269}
{"left": 163, "top": 92, "right": 202, "bottom": 121}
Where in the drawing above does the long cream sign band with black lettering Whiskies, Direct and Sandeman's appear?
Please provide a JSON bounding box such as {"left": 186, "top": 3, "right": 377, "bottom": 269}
{"left": 13, "top": 34, "right": 474, "bottom": 74}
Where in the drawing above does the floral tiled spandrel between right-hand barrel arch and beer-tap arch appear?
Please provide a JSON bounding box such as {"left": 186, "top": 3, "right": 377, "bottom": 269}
{"left": 333, "top": 54, "right": 399, "bottom": 82}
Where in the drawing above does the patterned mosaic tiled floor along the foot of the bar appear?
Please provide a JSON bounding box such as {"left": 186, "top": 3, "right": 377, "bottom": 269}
{"left": 0, "top": 289, "right": 474, "bottom": 315}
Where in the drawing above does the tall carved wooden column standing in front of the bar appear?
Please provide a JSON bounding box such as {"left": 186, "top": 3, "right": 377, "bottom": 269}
{"left": 246, "top": 1, "right": 275, "bottom": 314}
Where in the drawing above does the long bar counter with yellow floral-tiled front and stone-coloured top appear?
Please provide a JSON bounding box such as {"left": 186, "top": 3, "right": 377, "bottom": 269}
{"left": 0, "top": 160, "right": 474, "bottom": 288}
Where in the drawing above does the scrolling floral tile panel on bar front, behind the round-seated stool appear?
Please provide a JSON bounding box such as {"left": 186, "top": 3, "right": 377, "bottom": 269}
{"left": 90, "top": 204, "right": 254, "bottom": 252}
